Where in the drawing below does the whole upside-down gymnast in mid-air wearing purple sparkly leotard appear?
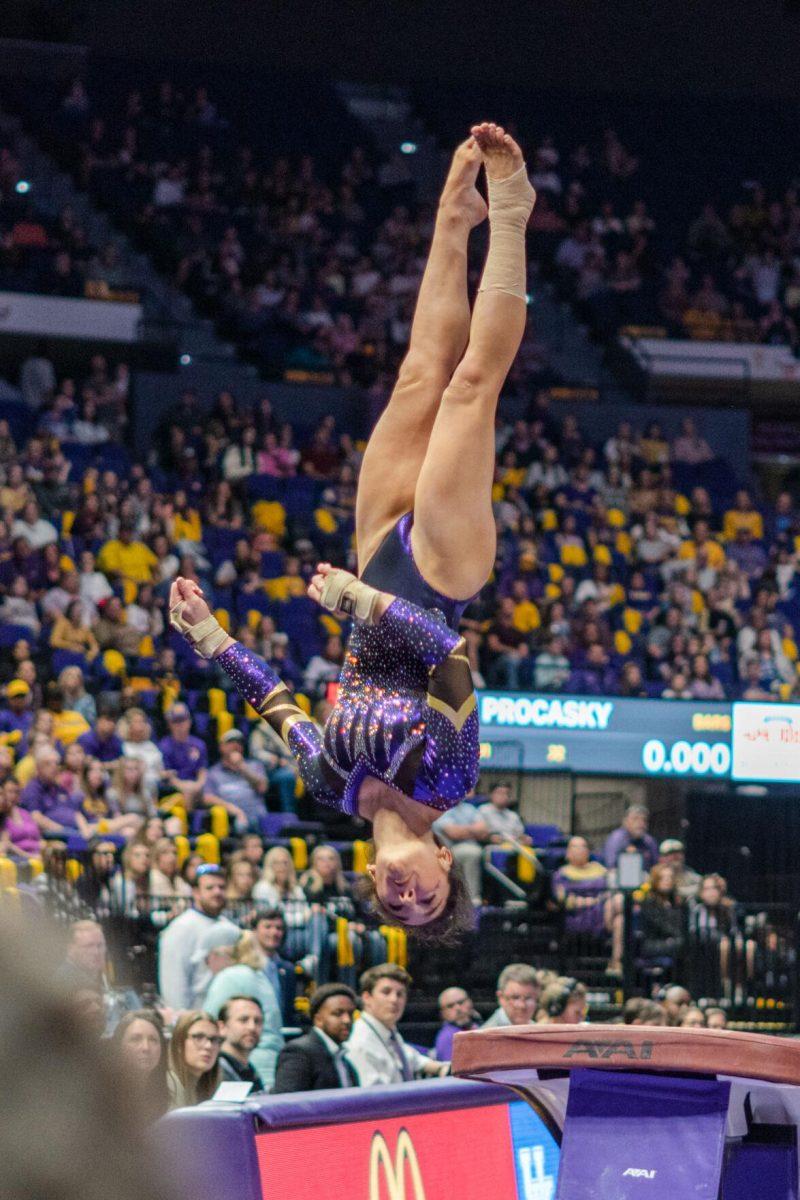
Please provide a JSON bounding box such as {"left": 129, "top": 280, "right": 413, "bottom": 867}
{"left": 169, "top": 124, "right": 535, "bottom": 941}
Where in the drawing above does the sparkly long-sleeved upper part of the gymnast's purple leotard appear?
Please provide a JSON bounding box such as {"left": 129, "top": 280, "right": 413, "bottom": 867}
{"left": 217, "top": 599, "right": 479, "bottom": 815}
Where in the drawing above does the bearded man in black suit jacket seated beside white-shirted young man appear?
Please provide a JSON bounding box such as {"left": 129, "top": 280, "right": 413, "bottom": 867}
{"left": 272, "top": 983, "right": 359, "bottom": 1092}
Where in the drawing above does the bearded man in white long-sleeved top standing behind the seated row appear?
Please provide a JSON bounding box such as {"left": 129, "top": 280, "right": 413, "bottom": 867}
{"left": 158, "top": 863, "right": 240, "bottom": 1010}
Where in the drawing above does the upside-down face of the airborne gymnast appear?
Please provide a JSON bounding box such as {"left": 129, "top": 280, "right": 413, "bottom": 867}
{"left": 367, "top": 838, "right": 453, "bottom": 925}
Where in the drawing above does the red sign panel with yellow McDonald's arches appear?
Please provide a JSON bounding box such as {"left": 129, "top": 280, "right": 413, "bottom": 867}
{"left": 255, "top": 1104, "right": 517, "bottom": 1200}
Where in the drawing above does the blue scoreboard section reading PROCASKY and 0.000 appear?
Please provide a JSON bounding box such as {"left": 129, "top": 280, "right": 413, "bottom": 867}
{"left": 479, "top": 691, "right": 734, "bottom": 779}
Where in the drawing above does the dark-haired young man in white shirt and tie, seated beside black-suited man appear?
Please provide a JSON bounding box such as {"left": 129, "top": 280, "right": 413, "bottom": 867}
{"left": 345, "top": 962, "right": 450, "bottom": 1087}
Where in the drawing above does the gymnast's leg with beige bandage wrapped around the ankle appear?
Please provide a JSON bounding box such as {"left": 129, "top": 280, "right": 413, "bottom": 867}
{"left": 411, "top": 125, "right": 535, "bottom": 599}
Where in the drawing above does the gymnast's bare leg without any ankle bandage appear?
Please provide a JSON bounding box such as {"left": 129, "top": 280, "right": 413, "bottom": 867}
{"left": 356, "top": 138, "right": 486, "bottom": 572}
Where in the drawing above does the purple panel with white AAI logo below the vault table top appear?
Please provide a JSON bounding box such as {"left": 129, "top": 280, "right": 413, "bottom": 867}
{"left": 557, "top": 1070, "right": 730, "bottom": 1200}
